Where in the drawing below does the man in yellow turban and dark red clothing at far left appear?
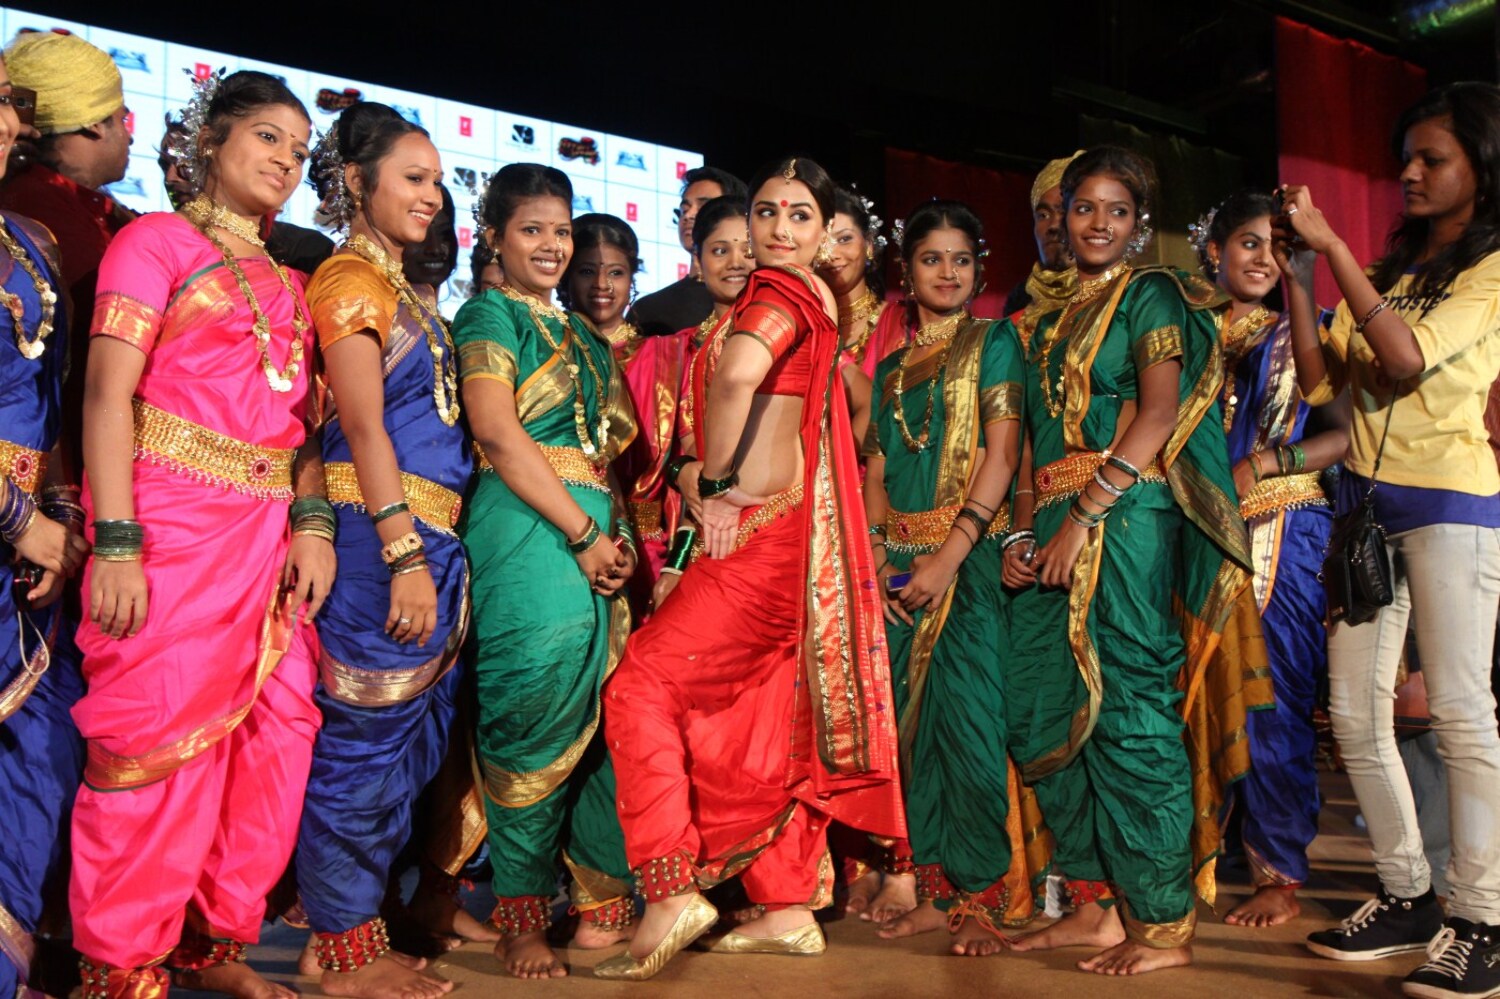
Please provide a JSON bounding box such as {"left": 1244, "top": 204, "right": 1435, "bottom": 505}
{"left": 0, "top": 32, "right": 135, "bottom": 482}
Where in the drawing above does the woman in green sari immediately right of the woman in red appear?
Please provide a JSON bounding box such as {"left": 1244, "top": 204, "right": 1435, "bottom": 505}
{"left": 864, "top": 201, "right": 1029, "bottom": 956}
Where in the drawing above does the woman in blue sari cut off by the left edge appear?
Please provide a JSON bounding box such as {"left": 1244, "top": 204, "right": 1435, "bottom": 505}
{"left": 0, "top": 63, "right": 89, "bottom": 996}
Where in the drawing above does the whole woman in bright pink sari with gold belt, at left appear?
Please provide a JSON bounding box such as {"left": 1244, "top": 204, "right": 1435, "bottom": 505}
{"left": 69, "top": 72, "right": 333, "bottom": 999}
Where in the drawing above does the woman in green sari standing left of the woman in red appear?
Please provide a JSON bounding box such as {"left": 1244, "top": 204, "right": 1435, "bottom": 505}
{"left": 453, "top": 164, "right": 636, "bottom": 978}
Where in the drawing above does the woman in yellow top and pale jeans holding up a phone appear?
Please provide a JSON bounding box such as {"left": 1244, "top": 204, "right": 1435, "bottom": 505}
{"left": 1277, "top": 83, "right": 1500, "bottom": 998}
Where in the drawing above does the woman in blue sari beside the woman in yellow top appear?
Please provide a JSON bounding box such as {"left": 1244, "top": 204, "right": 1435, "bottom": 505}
{"left": 1194, "top": 192, "right": 1349, "bottom": 927}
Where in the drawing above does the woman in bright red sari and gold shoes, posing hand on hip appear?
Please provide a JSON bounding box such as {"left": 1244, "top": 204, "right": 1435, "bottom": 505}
{"left": 594, "top": 158, "right": 905, "bottom": 980}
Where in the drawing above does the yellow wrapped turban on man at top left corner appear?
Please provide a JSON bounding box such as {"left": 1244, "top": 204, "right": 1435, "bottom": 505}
{"left": 5, "top": 32, "right": 125, "bottom": 135}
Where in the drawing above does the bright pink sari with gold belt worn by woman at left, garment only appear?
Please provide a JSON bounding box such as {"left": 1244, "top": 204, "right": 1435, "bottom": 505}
{"left": 71, "top": 213, "right": 318, "bottom": 968}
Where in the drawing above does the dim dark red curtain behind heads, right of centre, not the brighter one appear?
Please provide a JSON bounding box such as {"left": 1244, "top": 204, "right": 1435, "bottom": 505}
{"left": 875, "top": 149, "right": 1032, "bottom": 318}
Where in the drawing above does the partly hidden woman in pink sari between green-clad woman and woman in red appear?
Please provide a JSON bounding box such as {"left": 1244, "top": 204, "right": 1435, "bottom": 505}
{"left": 558, "top": 212, "right": 687, "bottom": 615}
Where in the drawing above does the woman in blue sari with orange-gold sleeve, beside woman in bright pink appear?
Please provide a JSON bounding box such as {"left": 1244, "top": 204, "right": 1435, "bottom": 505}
{"left": 297, "top": 104, "right": 473, "bottom": 999}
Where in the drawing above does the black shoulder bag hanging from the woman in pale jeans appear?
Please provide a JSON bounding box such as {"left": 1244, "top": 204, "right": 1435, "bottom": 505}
{"left": 1319, "top": 392, "right": 1397, "bottom": 624}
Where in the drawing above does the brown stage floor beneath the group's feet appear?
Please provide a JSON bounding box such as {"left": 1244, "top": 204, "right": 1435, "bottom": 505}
{"left": 231, "top": 773, "right": 1421, "bottom": 999}
